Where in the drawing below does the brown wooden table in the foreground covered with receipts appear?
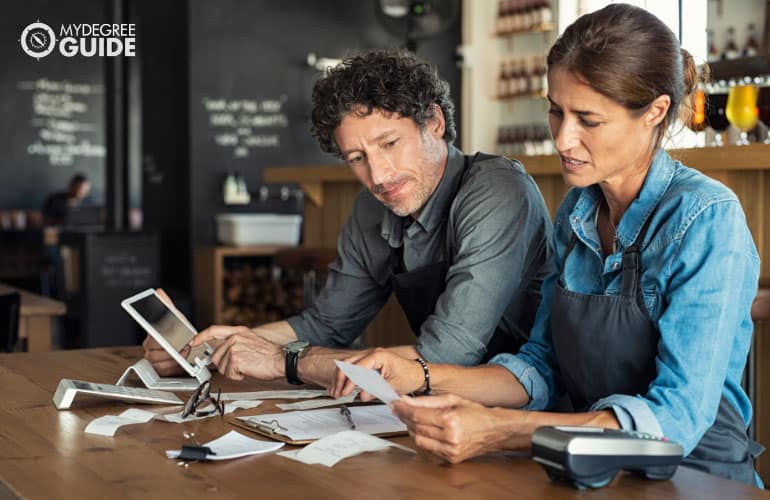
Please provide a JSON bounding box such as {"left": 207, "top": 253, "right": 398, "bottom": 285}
{"left": 0, "top": 347, "right": 766, "bottom": 500}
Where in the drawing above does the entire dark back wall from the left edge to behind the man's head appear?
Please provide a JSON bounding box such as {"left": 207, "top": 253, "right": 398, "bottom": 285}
{"left": 0, "top": 0, "right": 460, "bottom": 301}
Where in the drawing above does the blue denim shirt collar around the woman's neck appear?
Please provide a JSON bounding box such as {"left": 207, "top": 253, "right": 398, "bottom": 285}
{"left": 570, "top": 149, "right": 676, "bottom": 248}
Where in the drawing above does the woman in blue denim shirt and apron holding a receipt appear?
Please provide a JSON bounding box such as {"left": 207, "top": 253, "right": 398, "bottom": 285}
{"left": 332, "top": 4, "right": 759, "bottom": 484}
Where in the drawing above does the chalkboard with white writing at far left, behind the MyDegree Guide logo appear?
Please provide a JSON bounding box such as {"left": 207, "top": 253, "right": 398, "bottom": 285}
{"left": 0, "top": 0, "right": 107, "bottom": 209}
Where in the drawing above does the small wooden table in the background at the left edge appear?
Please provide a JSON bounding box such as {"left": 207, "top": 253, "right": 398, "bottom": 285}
{"left": 0, "top": 283, "right": 67, "bottom": 352}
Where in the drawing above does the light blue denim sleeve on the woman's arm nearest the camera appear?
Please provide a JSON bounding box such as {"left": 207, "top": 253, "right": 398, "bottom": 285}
{"left": 644, "top": 200, "right": 759, "bottom": 454}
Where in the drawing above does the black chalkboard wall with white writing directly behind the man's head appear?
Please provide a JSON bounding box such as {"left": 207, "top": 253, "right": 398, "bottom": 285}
{"left": 189, "top": 0, "right": 460, "bottom": 245}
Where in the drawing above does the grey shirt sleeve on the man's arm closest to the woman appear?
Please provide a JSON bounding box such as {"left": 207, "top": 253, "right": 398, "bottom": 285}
{"left": 417, "top": 165, "right": 551, "bottom": 366}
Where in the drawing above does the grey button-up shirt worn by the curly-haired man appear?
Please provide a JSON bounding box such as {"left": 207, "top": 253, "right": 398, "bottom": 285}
{"left": 288, "top": 146, "right": 552, "bottom": 365}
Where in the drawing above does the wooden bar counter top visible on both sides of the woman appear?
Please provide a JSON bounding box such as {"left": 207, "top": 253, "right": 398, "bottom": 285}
{"left": 517, "top": 144, "right": 770, "bottom": 175}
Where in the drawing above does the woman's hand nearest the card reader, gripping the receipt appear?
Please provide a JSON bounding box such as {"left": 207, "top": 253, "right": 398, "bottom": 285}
{"left": 392, "top": 394, "right": 520, "bottom": 464}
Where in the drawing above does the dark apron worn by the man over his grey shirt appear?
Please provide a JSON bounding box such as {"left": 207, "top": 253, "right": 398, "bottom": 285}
{"left": 390, "top": 153, "right": 510, "bottom": 361}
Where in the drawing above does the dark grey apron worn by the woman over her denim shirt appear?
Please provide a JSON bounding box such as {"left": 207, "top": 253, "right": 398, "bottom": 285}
{"left": 551, "top": 215, "right": 761, "bottom": 485}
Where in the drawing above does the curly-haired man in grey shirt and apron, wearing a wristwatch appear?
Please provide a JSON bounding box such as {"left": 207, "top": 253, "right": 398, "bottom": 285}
{"left": 145, "top": 51, "right": 551, "bottom": 386}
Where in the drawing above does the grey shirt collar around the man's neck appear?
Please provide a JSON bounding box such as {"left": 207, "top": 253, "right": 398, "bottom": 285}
{"left": 380, "top": 144, "right": 465, "bottom": 248}
